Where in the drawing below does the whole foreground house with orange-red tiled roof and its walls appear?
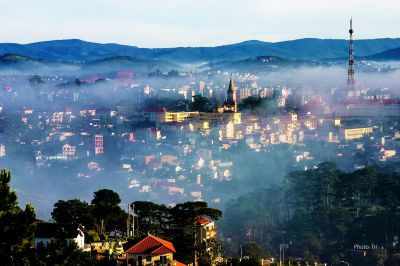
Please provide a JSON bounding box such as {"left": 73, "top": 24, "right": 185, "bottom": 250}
{"left": 123, "top": 234, "right": 181, "bottom": 266}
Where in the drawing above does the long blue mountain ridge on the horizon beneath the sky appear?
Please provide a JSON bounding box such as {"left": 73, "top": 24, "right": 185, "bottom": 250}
{"left": 0, "top": 38, "right": 400, "bottom": 63}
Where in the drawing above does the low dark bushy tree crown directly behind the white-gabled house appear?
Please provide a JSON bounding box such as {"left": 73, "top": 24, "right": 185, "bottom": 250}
{"left": 51, "top": 199, "right": 93, "bottom": 226}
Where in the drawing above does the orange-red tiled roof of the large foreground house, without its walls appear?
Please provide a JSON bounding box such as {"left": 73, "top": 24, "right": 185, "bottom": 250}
{"left": 125, "top": 234, "right": 176, "bottom": 254}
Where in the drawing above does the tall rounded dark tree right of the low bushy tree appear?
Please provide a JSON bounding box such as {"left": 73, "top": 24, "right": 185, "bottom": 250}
{"left": 92, "top": 189, "right": 126, "bottom": 233}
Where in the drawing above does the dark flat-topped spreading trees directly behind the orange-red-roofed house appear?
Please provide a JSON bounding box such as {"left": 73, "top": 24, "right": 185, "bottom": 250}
{"left": 133, "top": 201, "right": 222, "bottom": 265}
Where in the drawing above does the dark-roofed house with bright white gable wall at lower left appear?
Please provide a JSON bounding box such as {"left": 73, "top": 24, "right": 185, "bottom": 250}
{"left": 35, "top": 223, "right": 85, "bottom": 250}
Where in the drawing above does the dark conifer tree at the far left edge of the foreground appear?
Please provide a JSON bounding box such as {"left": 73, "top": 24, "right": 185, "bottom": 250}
{"left": 0, "top": 169, "right": 36, "bottom": 265}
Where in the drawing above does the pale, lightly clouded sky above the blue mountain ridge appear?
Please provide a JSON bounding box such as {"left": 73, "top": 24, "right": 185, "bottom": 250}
{"left": 0, "top": 0, "right": 400, "bottom": 47}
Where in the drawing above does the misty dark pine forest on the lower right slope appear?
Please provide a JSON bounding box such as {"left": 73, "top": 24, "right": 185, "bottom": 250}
{"left": 221, "top": 162, "right": 400, "bottom": 265}
